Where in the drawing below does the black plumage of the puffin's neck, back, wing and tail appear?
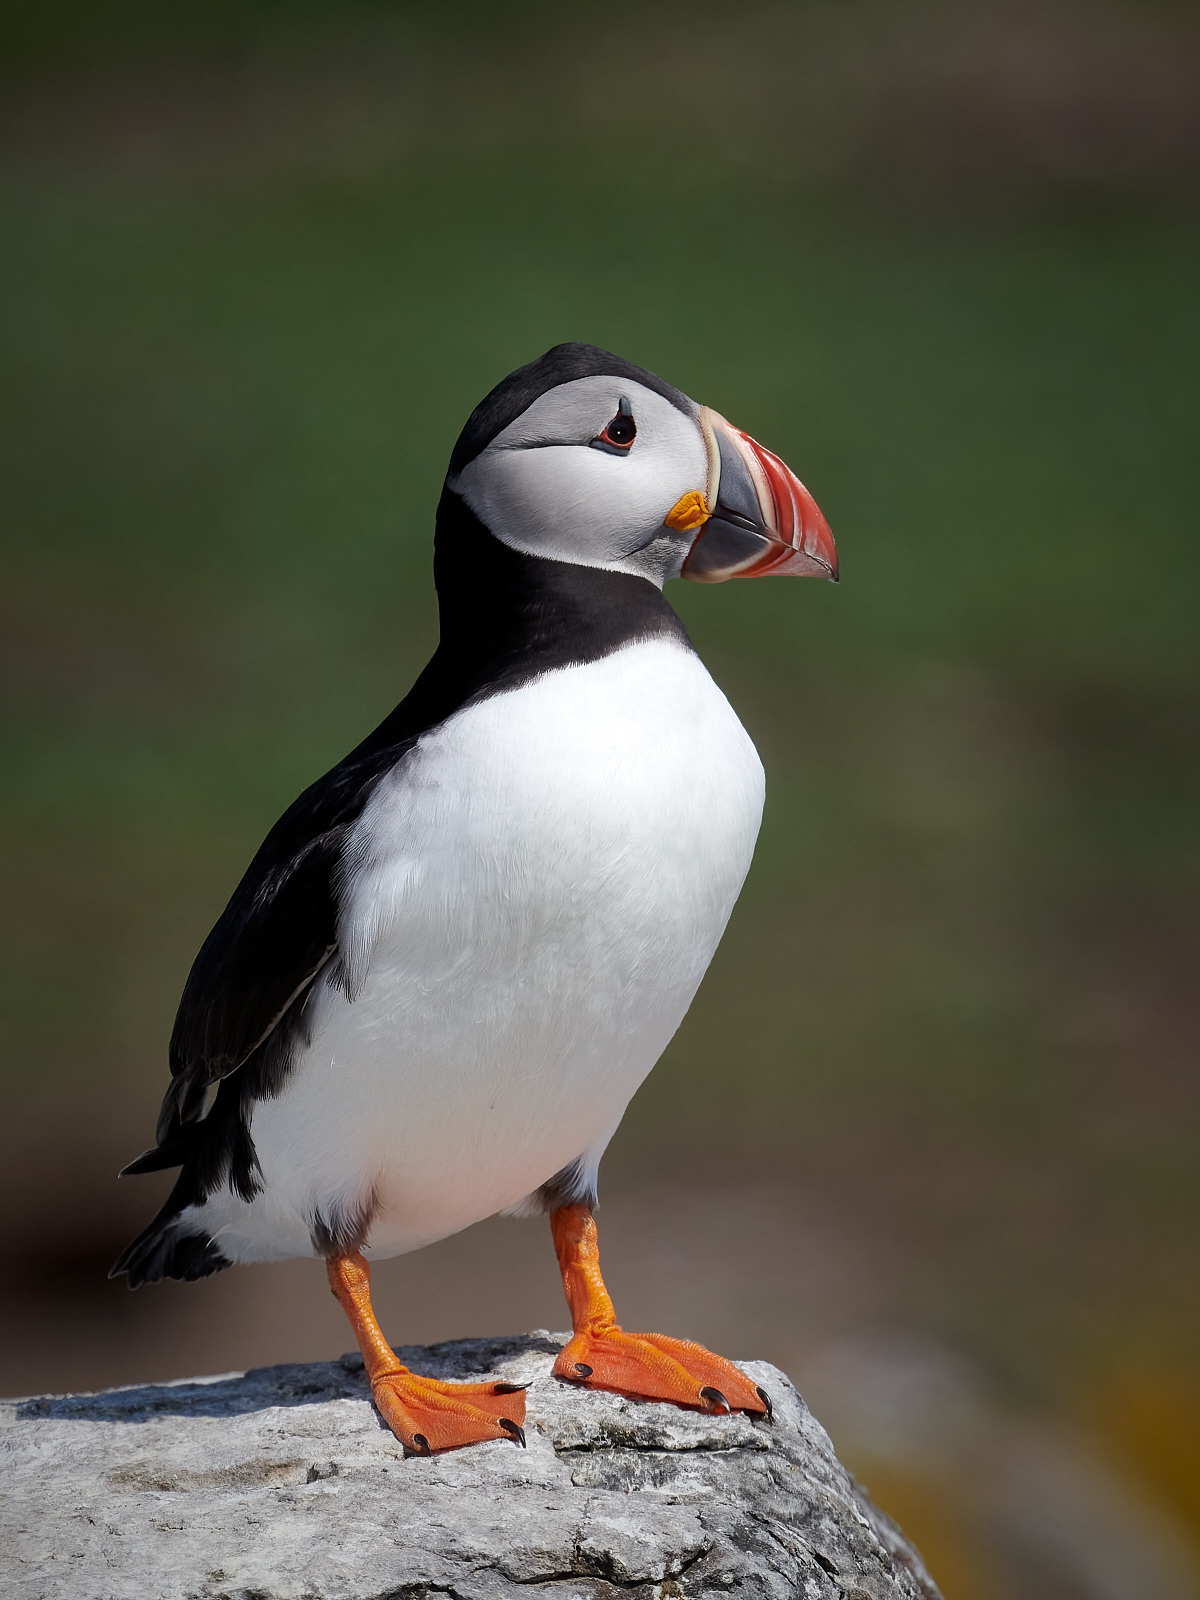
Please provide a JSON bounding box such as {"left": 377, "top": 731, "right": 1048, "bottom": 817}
{"left": 114, "top": 483, "right": 690, "bottom": 1286}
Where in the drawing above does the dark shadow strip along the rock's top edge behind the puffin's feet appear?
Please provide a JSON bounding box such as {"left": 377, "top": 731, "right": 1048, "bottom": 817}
{"left": 14, "top": 1334, "right": 560, "bottom": 1422}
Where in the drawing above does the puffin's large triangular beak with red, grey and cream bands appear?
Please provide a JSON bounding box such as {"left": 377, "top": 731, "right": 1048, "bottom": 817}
{"left": 682, "top": 406, "right": 838, "bottom": 584}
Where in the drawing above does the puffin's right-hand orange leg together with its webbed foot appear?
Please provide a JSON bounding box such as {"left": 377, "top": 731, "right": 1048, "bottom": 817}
{"left": 550, "top": 1205, "right": 771, "bottom": 1416}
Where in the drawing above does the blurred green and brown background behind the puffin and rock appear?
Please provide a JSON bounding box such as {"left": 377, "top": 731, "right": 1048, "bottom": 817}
{"left": 0, "top": 0, "right": 1200, "bottom": 1600}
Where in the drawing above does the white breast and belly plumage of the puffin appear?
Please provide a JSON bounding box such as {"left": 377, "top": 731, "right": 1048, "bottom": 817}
{"left": 197, "top": 640, "right": 763, "bottom": 1261}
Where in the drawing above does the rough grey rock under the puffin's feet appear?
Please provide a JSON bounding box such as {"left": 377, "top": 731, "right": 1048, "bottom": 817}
{"left": 0, "top": 1334, "right": 938, "bottom": 1600}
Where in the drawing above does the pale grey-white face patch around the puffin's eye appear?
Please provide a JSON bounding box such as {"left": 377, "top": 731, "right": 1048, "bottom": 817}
{"left": 450, "top": 376, "right": 709, "bottom": 586}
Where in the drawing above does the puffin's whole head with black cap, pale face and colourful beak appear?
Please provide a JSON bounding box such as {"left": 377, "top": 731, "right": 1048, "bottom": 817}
{"left": 446, "top": 344, "right": 837, "bottom": 587}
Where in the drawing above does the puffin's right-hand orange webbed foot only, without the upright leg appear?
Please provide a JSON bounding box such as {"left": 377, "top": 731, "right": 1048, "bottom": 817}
{"left": 554, "top": 1326, "right": 771, "bottom": 1416}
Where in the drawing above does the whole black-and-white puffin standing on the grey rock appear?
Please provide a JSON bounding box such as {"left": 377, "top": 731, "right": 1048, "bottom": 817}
{"left": 110, "top": 344, "right": 838, "bottom": 1454}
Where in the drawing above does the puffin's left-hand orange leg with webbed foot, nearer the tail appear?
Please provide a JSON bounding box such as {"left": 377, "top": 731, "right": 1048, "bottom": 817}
{"left": 328, "top": 1250, "right": 525, "bottom": 1456}
